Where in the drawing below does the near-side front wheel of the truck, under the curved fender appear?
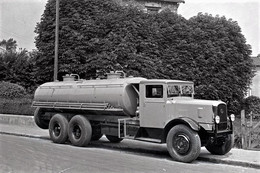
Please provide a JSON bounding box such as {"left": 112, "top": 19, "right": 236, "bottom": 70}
{"left": 166, "top": 124, "right": 201, "bottom": 163}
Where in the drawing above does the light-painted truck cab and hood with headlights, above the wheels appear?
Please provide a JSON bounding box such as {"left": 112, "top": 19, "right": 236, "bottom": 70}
{"left": 139, "top": 80, "right": 233, "bottom": 131}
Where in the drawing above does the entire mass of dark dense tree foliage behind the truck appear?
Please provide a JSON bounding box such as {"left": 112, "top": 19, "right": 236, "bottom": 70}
{"left": 35, "top": 0, "right": 254, "bottom": 113}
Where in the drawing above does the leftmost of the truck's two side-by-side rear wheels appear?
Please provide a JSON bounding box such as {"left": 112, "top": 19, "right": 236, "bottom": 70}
{"left": 49, "top": 114, "right": 69, "bottom": 144}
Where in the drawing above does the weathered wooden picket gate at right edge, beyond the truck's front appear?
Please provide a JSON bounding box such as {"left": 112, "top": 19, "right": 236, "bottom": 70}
{"left": 241, "top": 110, "right": 260, "bottom": 150}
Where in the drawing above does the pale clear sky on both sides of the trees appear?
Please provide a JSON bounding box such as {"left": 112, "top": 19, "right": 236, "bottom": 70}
{"left": 0, "top": 0, "right": 260, "bottom": 56}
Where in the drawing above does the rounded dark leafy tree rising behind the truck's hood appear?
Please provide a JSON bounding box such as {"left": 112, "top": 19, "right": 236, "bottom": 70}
{"left": 187, "top": 13, "right": 254, "bottom": 113}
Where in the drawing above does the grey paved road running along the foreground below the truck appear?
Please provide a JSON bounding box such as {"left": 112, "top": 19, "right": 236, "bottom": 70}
{"left": 0, "top": 134, "right": 259, "bottom": 173}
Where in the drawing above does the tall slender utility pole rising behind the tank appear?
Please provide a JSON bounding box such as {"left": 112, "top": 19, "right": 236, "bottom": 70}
{"left": 54, "top": 0, "right": 60, "bottom": 81}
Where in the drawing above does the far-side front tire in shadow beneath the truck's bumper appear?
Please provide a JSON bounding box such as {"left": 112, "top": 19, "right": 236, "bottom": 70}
{"left": 205, "top": 134, "right": 234, "bottom": 155}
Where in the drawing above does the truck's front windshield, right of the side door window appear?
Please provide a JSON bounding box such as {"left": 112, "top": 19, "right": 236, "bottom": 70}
{"left": 167, "top": 84, "right": 194, "bottom": 97}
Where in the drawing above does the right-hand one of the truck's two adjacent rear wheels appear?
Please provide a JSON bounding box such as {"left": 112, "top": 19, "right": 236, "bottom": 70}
{"left": 68, "top": 115, "right": 92, "bottom": 147}
